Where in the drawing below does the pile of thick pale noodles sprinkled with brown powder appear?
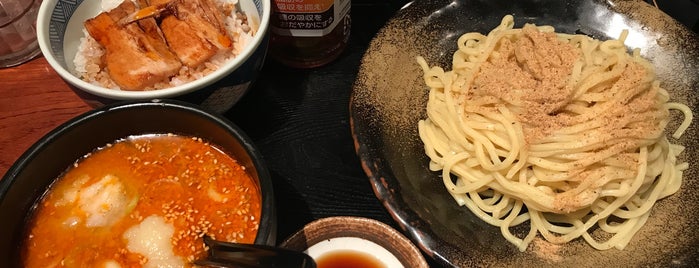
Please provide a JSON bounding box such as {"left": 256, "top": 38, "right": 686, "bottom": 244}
{"left": 417, "top": 15, "right": 692, "bottom": 251}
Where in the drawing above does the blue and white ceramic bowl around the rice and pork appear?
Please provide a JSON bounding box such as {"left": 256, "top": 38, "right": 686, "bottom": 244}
{"left": 37, "top": 0, "right": 271, "bottom": 112}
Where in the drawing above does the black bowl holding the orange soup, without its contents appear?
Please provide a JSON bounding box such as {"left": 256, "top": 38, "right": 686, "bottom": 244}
{"left": 0, "top": 100, "right": 277, "bottom": 267}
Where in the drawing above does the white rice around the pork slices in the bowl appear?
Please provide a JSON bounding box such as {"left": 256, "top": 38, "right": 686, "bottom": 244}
{"left": 73, "top": 0, "right": 255, "bottom": 90}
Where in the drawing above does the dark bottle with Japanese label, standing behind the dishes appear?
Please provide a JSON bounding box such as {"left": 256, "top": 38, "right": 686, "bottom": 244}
{"left": 269, "top": 0, "right": 351, "bottom": 68}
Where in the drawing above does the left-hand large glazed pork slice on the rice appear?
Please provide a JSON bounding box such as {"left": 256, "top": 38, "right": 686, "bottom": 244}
{"left": 85, "top": 1, "right": 182, "bottom": 90}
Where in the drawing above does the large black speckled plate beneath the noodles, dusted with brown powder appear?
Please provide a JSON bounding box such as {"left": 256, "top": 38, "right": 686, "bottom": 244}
{"left": 350, "top": 0, "right": 699, "bottom": 267}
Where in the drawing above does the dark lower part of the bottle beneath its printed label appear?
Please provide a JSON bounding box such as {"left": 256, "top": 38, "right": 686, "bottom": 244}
{"left": 269, "top": 13, "right": 352, "bottom": 68}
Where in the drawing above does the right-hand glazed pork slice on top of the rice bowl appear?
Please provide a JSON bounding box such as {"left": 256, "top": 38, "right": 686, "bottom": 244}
{"left": 159, "top": 0, "right": 233, "bottom": 67}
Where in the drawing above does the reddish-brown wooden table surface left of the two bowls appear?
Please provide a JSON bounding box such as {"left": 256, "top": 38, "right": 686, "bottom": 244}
{"left": 0, "top": 56, "right": 92, "bottom": 178}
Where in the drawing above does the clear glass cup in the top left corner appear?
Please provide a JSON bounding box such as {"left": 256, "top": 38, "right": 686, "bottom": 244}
{"left": 0, "top": 0, "right": 42, "bottom": 68}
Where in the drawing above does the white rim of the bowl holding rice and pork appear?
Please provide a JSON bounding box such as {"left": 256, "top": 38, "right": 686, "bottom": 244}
{"left": 36, "top": 0, "right": 272, "bottom": 100}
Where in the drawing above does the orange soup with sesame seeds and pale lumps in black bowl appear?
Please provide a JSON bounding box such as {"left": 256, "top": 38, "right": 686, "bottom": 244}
{"left": 23, "top": 134, "right": 261, "bottom": 267}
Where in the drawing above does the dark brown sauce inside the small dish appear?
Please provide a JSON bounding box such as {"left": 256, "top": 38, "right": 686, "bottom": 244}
{"left": 316, "top": 250, "right": 386, "bottom": 268}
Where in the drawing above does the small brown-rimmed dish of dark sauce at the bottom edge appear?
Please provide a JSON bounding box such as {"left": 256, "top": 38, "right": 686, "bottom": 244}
{"left": 281, "top": 216, "right": 429, "bottom": 268}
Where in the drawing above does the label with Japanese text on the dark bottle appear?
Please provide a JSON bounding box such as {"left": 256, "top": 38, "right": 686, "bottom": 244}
{"left": 271, "top": 0, "right": 351, "bottom": 37}
